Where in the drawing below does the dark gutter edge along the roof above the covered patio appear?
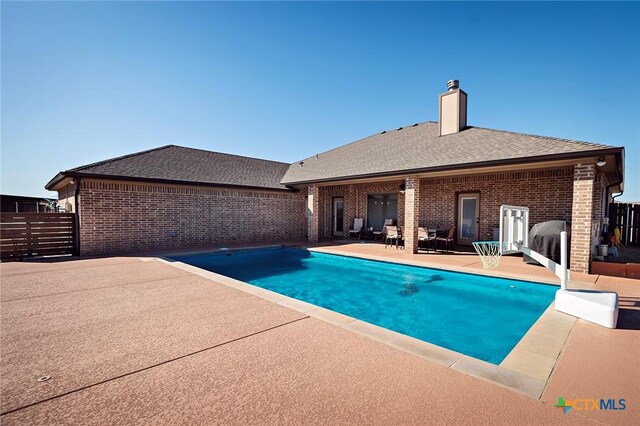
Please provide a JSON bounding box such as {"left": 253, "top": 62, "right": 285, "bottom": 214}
{"left": 283, "top": 147, "right": 624, "bottom": 185}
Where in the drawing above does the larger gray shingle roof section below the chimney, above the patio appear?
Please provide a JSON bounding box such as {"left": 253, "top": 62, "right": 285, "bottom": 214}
{"left": 282, "top": 122, "right": 614, "bottom": 184}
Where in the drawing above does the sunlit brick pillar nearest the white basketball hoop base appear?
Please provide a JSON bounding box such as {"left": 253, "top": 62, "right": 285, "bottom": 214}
{"left": 569, "top": 164, "right": 595, "bottom": 273}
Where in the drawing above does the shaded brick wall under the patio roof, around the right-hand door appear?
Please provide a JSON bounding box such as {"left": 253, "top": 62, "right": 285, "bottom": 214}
{"left": 420, "top": 167, "right": 573, "bottom": 240}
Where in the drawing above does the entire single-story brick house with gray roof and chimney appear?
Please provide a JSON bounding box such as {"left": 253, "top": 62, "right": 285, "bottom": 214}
{"left": 46, "top": 81, "right": 624, "bottom": 272}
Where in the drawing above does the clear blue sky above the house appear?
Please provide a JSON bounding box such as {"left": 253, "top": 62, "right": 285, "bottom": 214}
{"left": 0, "top": 2, "right": 640, "bottom": 201}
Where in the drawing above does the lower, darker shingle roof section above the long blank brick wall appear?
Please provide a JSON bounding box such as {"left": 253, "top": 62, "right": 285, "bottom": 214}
{"left": 57, "top": 145, "right": 289, "bottom": 189}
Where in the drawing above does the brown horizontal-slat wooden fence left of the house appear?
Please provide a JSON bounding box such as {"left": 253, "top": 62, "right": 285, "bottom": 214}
{"left": 0, "top": 213, "right": 78, "bottom": 260}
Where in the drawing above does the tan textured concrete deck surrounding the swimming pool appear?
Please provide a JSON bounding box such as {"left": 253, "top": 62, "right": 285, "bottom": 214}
{"left": 0, "top": 244, "right": 640, "bottom": 424}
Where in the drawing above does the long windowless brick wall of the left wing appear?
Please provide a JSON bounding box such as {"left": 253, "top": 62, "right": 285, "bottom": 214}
{"left": 75, "top": 179, "right": 306, "bottom": 255}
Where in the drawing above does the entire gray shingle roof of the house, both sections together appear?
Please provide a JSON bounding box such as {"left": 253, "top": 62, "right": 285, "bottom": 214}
{"left": 45, "top": 122, "right": 623, "bottom": 190}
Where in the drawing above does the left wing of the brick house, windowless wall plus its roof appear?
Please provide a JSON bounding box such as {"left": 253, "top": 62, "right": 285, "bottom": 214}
{"left": 46, "top": 145, "right": 306, "bottom": 255}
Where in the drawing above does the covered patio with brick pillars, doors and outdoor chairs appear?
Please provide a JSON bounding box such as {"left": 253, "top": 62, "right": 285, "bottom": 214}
{"left": 306, "top": 160, "right": 604, "bottom": 272}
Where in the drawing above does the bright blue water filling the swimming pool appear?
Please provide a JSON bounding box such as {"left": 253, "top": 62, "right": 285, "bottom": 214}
{"left": 169, "top": 248, "right": 557, "bottom": 364}
